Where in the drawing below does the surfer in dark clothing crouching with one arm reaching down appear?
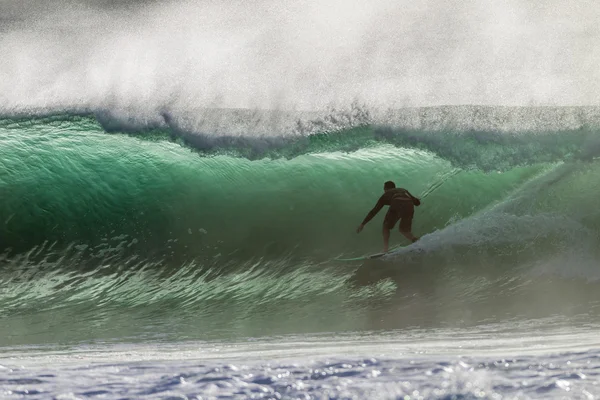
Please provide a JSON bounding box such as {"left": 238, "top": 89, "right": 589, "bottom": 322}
{"left": 356, "top": 181, "right": 421, "bottom": 253}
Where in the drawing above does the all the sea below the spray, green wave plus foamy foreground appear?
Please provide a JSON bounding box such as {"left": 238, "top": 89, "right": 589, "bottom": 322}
{"left": 0, "top": 107, "right": 600, "bottom": 399}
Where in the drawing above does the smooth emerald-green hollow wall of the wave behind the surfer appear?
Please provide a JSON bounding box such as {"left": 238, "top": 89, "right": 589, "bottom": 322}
{"left": 0, "top": 114, "right": 542, "bottom": 259}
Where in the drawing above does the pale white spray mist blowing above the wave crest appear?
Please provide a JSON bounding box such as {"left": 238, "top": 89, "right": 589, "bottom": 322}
{"left": 0, "top": 0, "right": 600, "bottom": 115}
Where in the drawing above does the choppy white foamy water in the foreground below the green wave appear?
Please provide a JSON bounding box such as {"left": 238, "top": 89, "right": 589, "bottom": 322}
{"left": 0, "top": 320, "right": 600, "bottom": 399}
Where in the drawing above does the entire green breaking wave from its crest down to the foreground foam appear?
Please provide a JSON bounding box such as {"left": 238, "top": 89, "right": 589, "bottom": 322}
{"left": 0, "top": 111, "right": 600, "bottom": 343}
